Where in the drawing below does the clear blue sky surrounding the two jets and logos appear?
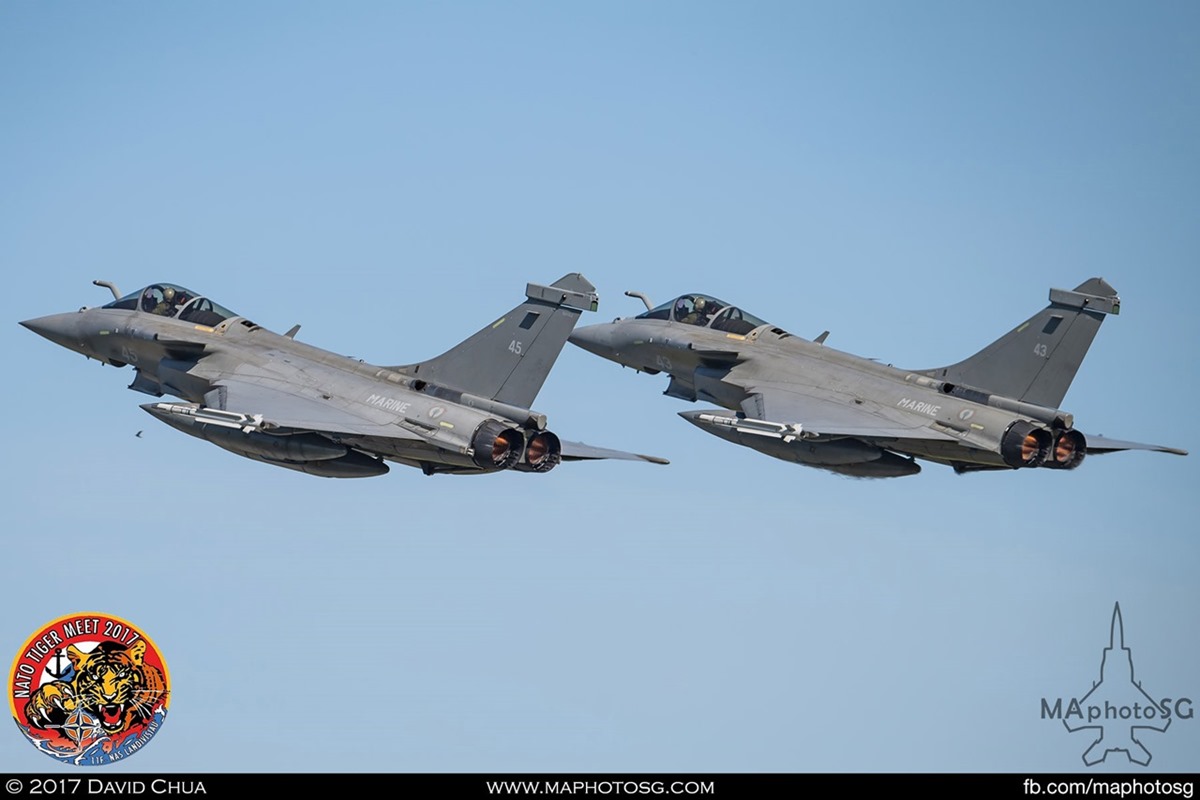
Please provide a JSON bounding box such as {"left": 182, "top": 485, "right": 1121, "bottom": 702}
{"left": 0, "top": 1, "right": 1200, "bottom": 772}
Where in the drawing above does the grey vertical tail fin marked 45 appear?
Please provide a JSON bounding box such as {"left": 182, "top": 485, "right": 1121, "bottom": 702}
{"left": 394, "top": 272, "right": 599, "bottom": 408}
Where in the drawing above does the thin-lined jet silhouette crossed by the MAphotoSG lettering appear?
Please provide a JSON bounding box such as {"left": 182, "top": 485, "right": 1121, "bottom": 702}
{"left": 1062, "top": 603, "right": 1171, "bottom": 766}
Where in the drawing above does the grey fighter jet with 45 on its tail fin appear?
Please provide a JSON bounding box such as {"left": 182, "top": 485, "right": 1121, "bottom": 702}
{"left": 20, "top": 273, "right": 667, "bottom": 477}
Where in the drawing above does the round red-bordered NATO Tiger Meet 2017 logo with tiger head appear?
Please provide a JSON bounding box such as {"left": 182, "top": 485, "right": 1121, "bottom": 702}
{"left": 8, "top": 613, "right": 170, "bottom": 766}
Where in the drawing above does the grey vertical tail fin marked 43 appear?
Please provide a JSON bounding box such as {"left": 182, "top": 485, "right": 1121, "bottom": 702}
{"left": 924, "top": 278, "right": 1121, "bottom": 408}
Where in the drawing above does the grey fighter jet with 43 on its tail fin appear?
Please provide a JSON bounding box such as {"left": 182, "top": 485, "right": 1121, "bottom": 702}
{"left": 570, "top": 278, "right": 1187, "bottom": 477}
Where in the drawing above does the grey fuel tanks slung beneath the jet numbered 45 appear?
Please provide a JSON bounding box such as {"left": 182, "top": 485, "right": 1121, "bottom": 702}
{"left": 142, "top": 403, "right": 389, "bottom": 477}
